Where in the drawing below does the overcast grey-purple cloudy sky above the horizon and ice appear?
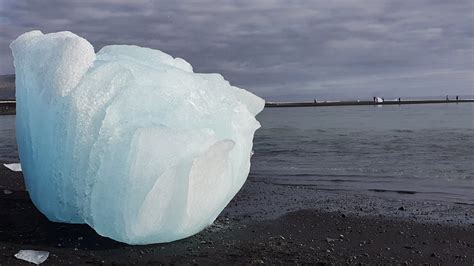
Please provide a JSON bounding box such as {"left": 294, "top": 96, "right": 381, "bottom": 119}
{"left": 0, "top": 0, "right": 474, "bottom": 100}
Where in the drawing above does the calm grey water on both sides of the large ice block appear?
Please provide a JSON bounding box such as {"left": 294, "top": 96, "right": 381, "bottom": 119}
{"left": 0, "top": 103, "right": 474, "bottom": 204}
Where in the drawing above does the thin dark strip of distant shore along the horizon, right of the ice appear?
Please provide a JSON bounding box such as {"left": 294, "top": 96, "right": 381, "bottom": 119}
{"left": 265, "top": 99, "right": 474, "bottom": 108}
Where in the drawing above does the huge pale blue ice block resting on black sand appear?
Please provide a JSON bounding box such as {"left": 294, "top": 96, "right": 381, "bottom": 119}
{"left": 10, "top": 31, "right": 264, "bottom": 244}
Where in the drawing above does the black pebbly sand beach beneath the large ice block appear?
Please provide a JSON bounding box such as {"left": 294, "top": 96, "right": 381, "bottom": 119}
{"left": 0, "top": 165, "right": 474, "bottom": 265}
